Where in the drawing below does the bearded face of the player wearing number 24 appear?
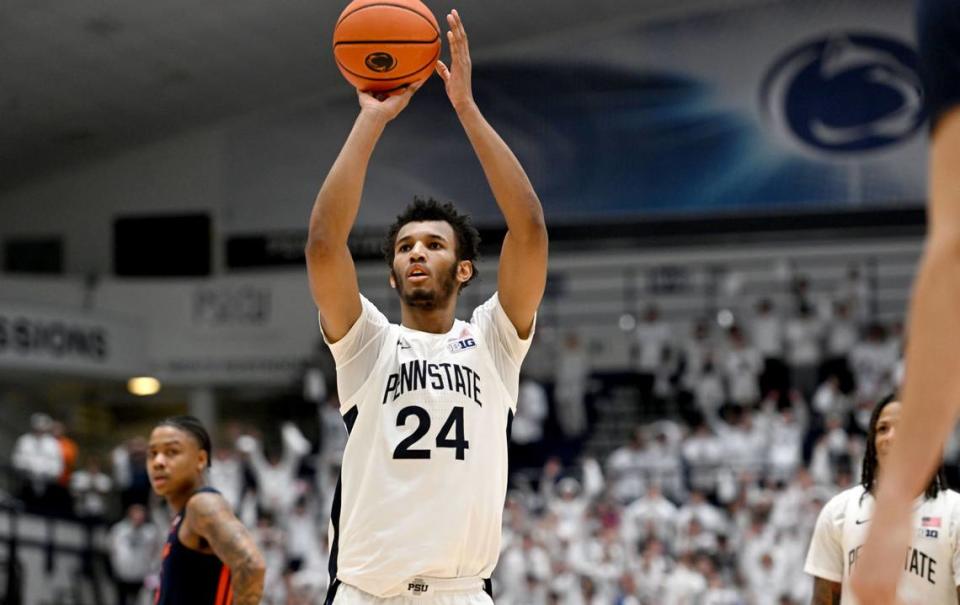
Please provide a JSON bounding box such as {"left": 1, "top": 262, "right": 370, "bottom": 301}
{"left": 390, "top": 221, "right": 469, "bottom": 308}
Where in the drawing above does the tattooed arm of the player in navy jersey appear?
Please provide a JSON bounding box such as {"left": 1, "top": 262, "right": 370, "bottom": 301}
{"left": 186, "top": 493, "right": 265, "bottom": 605}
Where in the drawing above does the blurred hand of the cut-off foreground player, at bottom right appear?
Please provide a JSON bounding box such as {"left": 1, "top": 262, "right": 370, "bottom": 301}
{"left": 850, "top": 505, "right": 911, "bottom": 605}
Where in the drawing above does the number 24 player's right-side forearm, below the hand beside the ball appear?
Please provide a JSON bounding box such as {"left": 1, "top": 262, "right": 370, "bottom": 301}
{"left": 456, "top": 102, "right": 546, "bottom": 241}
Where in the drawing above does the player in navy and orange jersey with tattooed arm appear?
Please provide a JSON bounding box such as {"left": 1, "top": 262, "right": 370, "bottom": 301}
{"left": 147, "top": 416, "right": 264, "bottom": 605}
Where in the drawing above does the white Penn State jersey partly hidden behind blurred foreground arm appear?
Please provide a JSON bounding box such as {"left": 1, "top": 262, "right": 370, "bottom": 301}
{"left": 803, "top": 485, "right": 960, "bottom": 605}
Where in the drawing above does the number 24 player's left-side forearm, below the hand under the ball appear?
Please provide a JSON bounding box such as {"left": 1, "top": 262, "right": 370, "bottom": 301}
{"left": 309, "top": 110, "right": 387, "bottom": 247}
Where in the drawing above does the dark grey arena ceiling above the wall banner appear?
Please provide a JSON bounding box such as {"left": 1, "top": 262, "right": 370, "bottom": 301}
{"left": 0, "top": 0, "right": 786, "bottom": 189}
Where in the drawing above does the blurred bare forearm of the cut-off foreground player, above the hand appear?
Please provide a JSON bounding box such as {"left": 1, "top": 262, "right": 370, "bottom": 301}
{"left": 880, "top": 236, "right": 960, "bottom": 508}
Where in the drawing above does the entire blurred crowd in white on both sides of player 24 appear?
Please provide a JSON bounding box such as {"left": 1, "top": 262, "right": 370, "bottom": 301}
{"left": 5, "top": 272, "right": 936, "bottom": 605}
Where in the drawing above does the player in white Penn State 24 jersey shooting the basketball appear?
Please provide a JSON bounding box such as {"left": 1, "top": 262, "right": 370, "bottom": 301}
{"left": 306, "top": 11, "right": 547, "bottom": 605}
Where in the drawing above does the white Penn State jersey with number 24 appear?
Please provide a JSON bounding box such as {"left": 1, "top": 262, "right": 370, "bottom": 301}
{"left": 320, "top": 294, "right": 530, "bottom": 597}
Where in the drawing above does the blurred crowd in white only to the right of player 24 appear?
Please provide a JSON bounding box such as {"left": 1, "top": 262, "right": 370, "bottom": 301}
{"left": 494, "top": 271, "right": 916, "bottom": 605}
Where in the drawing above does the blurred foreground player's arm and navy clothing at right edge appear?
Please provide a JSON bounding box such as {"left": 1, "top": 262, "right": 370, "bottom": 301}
{"left": 852, "top": 0, "right": 960, "bottom": 605}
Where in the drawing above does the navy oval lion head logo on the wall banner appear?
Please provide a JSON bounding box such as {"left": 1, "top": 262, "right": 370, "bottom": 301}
{"left": 760, "top": 32, "right": 926, "bottom": 154}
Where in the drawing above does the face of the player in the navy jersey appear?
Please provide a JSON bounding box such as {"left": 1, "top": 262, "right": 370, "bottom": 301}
{"left": 147, "top": 426, "right": 207, "bottom": 496}
